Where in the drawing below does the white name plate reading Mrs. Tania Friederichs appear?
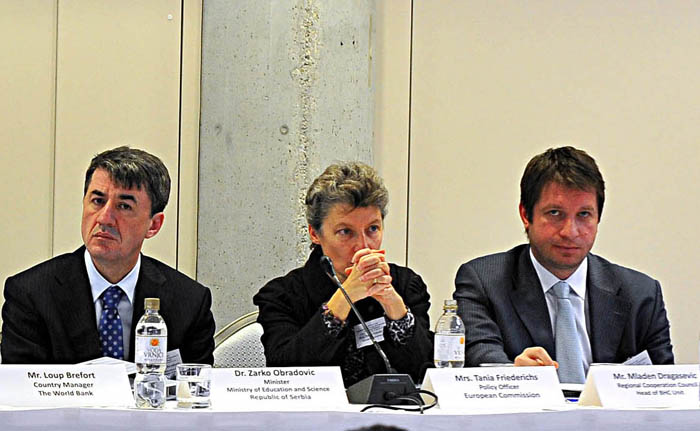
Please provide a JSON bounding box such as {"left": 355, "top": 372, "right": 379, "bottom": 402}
{"left": 422, "top": 367, "right": 565, "bottom": 412}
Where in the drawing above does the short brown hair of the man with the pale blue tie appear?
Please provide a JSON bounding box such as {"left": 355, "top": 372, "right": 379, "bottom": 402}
{"left": 520, "top": 147, "right": 605, "bottom": 221}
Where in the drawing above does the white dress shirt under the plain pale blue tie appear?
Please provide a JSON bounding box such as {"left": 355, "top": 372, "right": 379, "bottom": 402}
{"left": 530, "top": 248, "right": 593, "bottom": 372}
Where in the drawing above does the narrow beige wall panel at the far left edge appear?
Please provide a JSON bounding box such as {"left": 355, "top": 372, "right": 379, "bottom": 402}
{"left": 0, "top": 0, "right": 56, "bottom": 318}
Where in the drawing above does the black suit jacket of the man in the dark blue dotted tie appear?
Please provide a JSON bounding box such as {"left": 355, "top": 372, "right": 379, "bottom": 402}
{"left": 1, "top": 247, "right": 214, "bottom": 364}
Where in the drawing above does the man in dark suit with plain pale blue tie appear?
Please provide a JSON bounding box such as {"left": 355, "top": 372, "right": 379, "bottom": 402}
{"left": 453, "top": 147, "right": 673, "bottom": 383}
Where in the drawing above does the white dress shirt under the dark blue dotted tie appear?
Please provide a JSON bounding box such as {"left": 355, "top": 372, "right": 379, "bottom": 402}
{"left": 85, "top": 249, "right": 141, "bottom": 359}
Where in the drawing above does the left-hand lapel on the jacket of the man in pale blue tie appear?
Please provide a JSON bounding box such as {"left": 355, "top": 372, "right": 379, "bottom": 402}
{"left": 510, "top": 247, "right": 554, "bottom": 360}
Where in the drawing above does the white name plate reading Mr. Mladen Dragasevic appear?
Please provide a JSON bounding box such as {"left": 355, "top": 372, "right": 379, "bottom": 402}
{"left": 579, "top": 364, "right": 698, "bottom": 408}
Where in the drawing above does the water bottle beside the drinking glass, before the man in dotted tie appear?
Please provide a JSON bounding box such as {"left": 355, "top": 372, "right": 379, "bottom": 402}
{"left": 134, "top": 298, "right": 168, "bottom": 409}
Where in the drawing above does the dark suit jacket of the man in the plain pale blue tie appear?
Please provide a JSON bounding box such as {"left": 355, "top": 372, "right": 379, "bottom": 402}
{"left": 453, "top": 244, "right": 673, "bottom": 366}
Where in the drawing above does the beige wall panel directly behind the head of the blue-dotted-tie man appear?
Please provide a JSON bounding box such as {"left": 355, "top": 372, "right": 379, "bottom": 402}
{"left": 54, "top": 0, "right": 181, "bottom": 266}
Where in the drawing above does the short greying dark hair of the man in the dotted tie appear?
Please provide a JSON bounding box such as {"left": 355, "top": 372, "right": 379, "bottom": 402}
{"left": 83, "top": 147, "right": 170, "bottom": 216}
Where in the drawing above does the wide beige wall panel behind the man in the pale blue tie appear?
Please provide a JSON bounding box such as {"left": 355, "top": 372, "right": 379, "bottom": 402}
{"left": 408, "top": 0, "right": 700, "bottom": 362}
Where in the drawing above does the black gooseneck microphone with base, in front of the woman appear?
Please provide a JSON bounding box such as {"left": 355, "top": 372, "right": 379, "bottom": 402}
{"left": 321, "top": 255, "right": 422, "bottom": 404}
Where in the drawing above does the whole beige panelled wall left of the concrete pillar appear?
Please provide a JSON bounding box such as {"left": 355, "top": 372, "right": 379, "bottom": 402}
{"left": 0, "top": 0, "right": 201, "bottom": 328}
